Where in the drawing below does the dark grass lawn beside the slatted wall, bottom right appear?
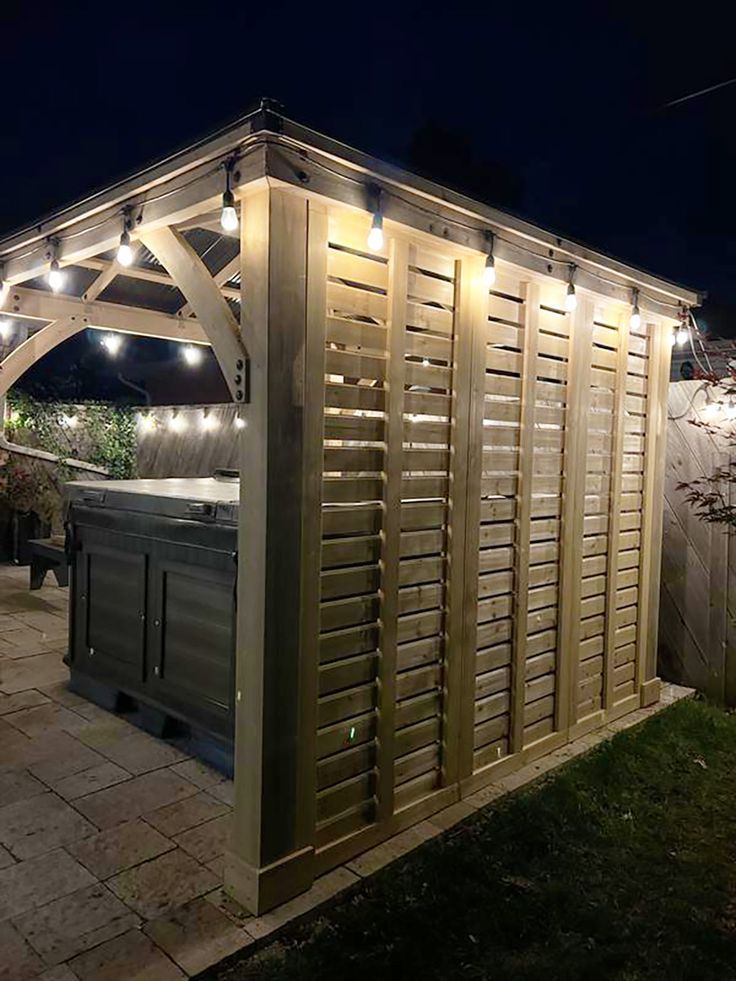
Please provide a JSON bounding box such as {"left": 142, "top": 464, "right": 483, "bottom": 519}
{"left": 208, "top": 701, "right": 736, "bottom": 981}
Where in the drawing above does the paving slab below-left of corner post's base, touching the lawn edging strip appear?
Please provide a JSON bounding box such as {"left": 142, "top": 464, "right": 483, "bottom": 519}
{"left": 143, "top": 899, "right": 253, "bottom": 974}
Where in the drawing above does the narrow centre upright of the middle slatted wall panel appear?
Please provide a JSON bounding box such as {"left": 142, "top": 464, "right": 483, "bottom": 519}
{"left": 509, "top": 283, "right": 539, "bottom": 753}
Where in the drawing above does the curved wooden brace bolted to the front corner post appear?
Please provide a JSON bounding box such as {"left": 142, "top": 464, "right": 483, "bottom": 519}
{"left": 139, "top": 227, "right": 248, "bottom": 403}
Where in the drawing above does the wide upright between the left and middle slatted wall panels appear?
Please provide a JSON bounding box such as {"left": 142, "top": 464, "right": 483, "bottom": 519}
{"left": 452, "top": 256, "right": 488, "bottom": 783}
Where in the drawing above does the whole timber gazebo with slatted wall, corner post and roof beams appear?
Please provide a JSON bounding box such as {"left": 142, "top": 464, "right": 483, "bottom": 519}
{"left": 0, "top": 107, "right": 699, "bottom": 912}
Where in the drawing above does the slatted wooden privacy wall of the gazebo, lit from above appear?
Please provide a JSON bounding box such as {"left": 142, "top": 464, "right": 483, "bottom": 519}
{"left": 308, "top": 207, "right": 668, "bottom": 867}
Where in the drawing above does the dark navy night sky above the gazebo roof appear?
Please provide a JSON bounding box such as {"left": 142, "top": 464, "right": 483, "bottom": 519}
{"left": 0, "top": 0, "right": 736, "bottom": 398}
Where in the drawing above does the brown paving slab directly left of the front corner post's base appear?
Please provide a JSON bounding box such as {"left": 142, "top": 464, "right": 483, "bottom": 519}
{"left": 107, "top": 848, "right": 220, "bottom": 920}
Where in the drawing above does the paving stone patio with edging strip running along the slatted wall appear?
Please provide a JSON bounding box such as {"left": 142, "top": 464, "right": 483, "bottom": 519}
{"left": 0, "top": 566, "right": 690, "bottom": 981}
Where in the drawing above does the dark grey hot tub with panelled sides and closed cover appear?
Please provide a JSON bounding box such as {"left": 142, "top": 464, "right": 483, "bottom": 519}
{"left": 68, "top": 478, "right": 239, "bottom": 769}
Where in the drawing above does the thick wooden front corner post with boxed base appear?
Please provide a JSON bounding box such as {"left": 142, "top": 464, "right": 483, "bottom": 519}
{"left": 225, "top": 189, "right": 326, "bottom": 913}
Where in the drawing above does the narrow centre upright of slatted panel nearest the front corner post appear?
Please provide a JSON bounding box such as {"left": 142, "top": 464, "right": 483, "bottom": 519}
{"left": 377, "top": 238, "right": 409, "bottom": 822}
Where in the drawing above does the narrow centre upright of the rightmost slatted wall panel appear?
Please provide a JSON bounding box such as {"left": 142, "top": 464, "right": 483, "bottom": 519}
{"left": 602, "top": 317, "right": 629, "bottom": 710}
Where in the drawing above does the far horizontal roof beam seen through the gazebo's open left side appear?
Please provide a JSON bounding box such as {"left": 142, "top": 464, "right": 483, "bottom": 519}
{"left": 4, "top": 286, "right": 207, "bottom": 343}
